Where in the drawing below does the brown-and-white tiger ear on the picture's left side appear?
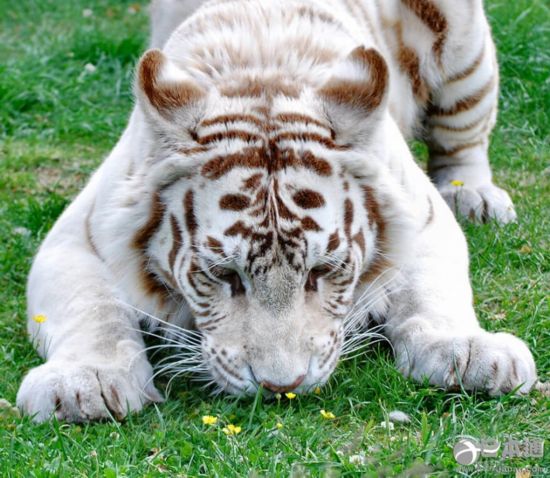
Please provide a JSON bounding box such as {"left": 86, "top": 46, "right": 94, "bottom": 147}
{"left": 136, "top": 49, "right": 206, "bottom": 120}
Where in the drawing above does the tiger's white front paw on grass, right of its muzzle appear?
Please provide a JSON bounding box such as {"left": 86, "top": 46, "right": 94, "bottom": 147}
{"left": 400, "top": 331, "right": 537, "bottom": 396}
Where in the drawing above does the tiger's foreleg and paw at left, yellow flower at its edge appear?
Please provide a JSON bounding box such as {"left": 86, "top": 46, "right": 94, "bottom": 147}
{"left": 17, "top": 170, "right": 162, "bottom": 421}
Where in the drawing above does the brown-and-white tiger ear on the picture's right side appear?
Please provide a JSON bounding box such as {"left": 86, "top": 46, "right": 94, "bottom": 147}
{"left": 318, "top": 46, "right": 389, "bottom": 141}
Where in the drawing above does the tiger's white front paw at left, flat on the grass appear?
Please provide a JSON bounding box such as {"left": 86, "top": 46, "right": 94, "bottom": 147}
{"left": 17, "top": 361, "right": 162, "bottom": 422}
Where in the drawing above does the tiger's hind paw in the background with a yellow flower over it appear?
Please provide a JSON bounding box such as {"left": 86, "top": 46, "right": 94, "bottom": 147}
{"left": 438, "top": 180, "right": 517, "bottom": 224}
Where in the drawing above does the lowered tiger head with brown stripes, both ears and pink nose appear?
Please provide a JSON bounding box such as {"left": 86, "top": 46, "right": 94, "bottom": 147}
{"left": 130, "top": 47, "right": 414, "bottom": 394}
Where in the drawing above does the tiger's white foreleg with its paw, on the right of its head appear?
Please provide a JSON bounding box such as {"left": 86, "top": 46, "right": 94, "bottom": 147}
{"left": 386, "top": 185, "right": 537, "bottom": 395}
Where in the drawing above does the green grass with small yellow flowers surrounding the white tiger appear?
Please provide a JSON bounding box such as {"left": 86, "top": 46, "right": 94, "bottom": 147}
{"left": 0, "top": 0, "right": 550, "bottom": 478}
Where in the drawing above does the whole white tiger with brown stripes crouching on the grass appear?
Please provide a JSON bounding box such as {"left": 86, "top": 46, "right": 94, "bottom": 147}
{"left": 17, "top": 0, "right": 537, "bottom": 421}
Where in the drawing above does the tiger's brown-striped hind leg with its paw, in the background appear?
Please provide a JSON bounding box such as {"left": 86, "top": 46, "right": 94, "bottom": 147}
{"left": 426, "top": 3, "right": 516, "bottom": 223}
